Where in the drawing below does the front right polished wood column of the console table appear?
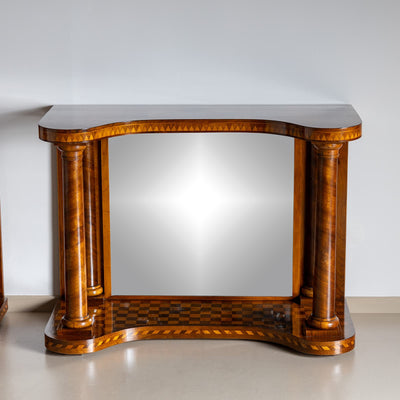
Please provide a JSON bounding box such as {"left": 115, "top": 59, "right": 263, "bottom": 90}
{"left": 307, "top": 142, "right": 342, "bottom": 329}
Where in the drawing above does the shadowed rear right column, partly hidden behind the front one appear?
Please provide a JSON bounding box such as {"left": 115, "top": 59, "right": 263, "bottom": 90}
{"left": 301, "top": 142, "right": 318, "bottom": 297}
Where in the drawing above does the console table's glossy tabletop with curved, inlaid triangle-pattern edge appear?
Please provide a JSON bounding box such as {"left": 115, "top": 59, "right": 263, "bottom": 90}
{"left": 39, "top": 104, "right": 361, "bottom": 142}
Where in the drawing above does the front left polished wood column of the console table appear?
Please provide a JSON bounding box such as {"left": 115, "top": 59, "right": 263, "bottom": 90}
{"left": 58, "top": 143, "right": 92, "bottom": 328}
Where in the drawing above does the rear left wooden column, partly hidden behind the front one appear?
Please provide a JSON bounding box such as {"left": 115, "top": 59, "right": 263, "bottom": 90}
{"left": 83, "top": 142, "right": 103, "bottom": 296}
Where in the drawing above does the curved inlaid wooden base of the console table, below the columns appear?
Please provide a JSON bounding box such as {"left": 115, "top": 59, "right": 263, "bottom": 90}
{"left": 45, "top": 296, "right": 355, "bottom": 355}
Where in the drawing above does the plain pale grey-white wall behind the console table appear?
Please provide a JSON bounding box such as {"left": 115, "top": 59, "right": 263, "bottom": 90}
{"left": 0, "top": 0, "right": 400, "bottom": 296}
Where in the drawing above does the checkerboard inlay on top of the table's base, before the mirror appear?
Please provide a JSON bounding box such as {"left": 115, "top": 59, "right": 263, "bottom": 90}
{"left": 55, "top": 300, "right": 292, "bottom": 333}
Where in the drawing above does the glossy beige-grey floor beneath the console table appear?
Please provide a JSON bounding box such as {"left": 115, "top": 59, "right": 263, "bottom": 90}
{"left": 0, "top": 313, "right": 400, "bottom": 400}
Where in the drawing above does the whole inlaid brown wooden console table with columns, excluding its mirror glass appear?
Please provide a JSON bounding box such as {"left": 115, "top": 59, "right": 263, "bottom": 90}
{"left": 39, "top": 105, "right": 361, "bottom": 355}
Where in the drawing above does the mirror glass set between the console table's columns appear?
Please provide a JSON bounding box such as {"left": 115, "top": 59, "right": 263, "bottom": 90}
{"left": 109, "top": 133, "right": 294, "bottom": 296}
